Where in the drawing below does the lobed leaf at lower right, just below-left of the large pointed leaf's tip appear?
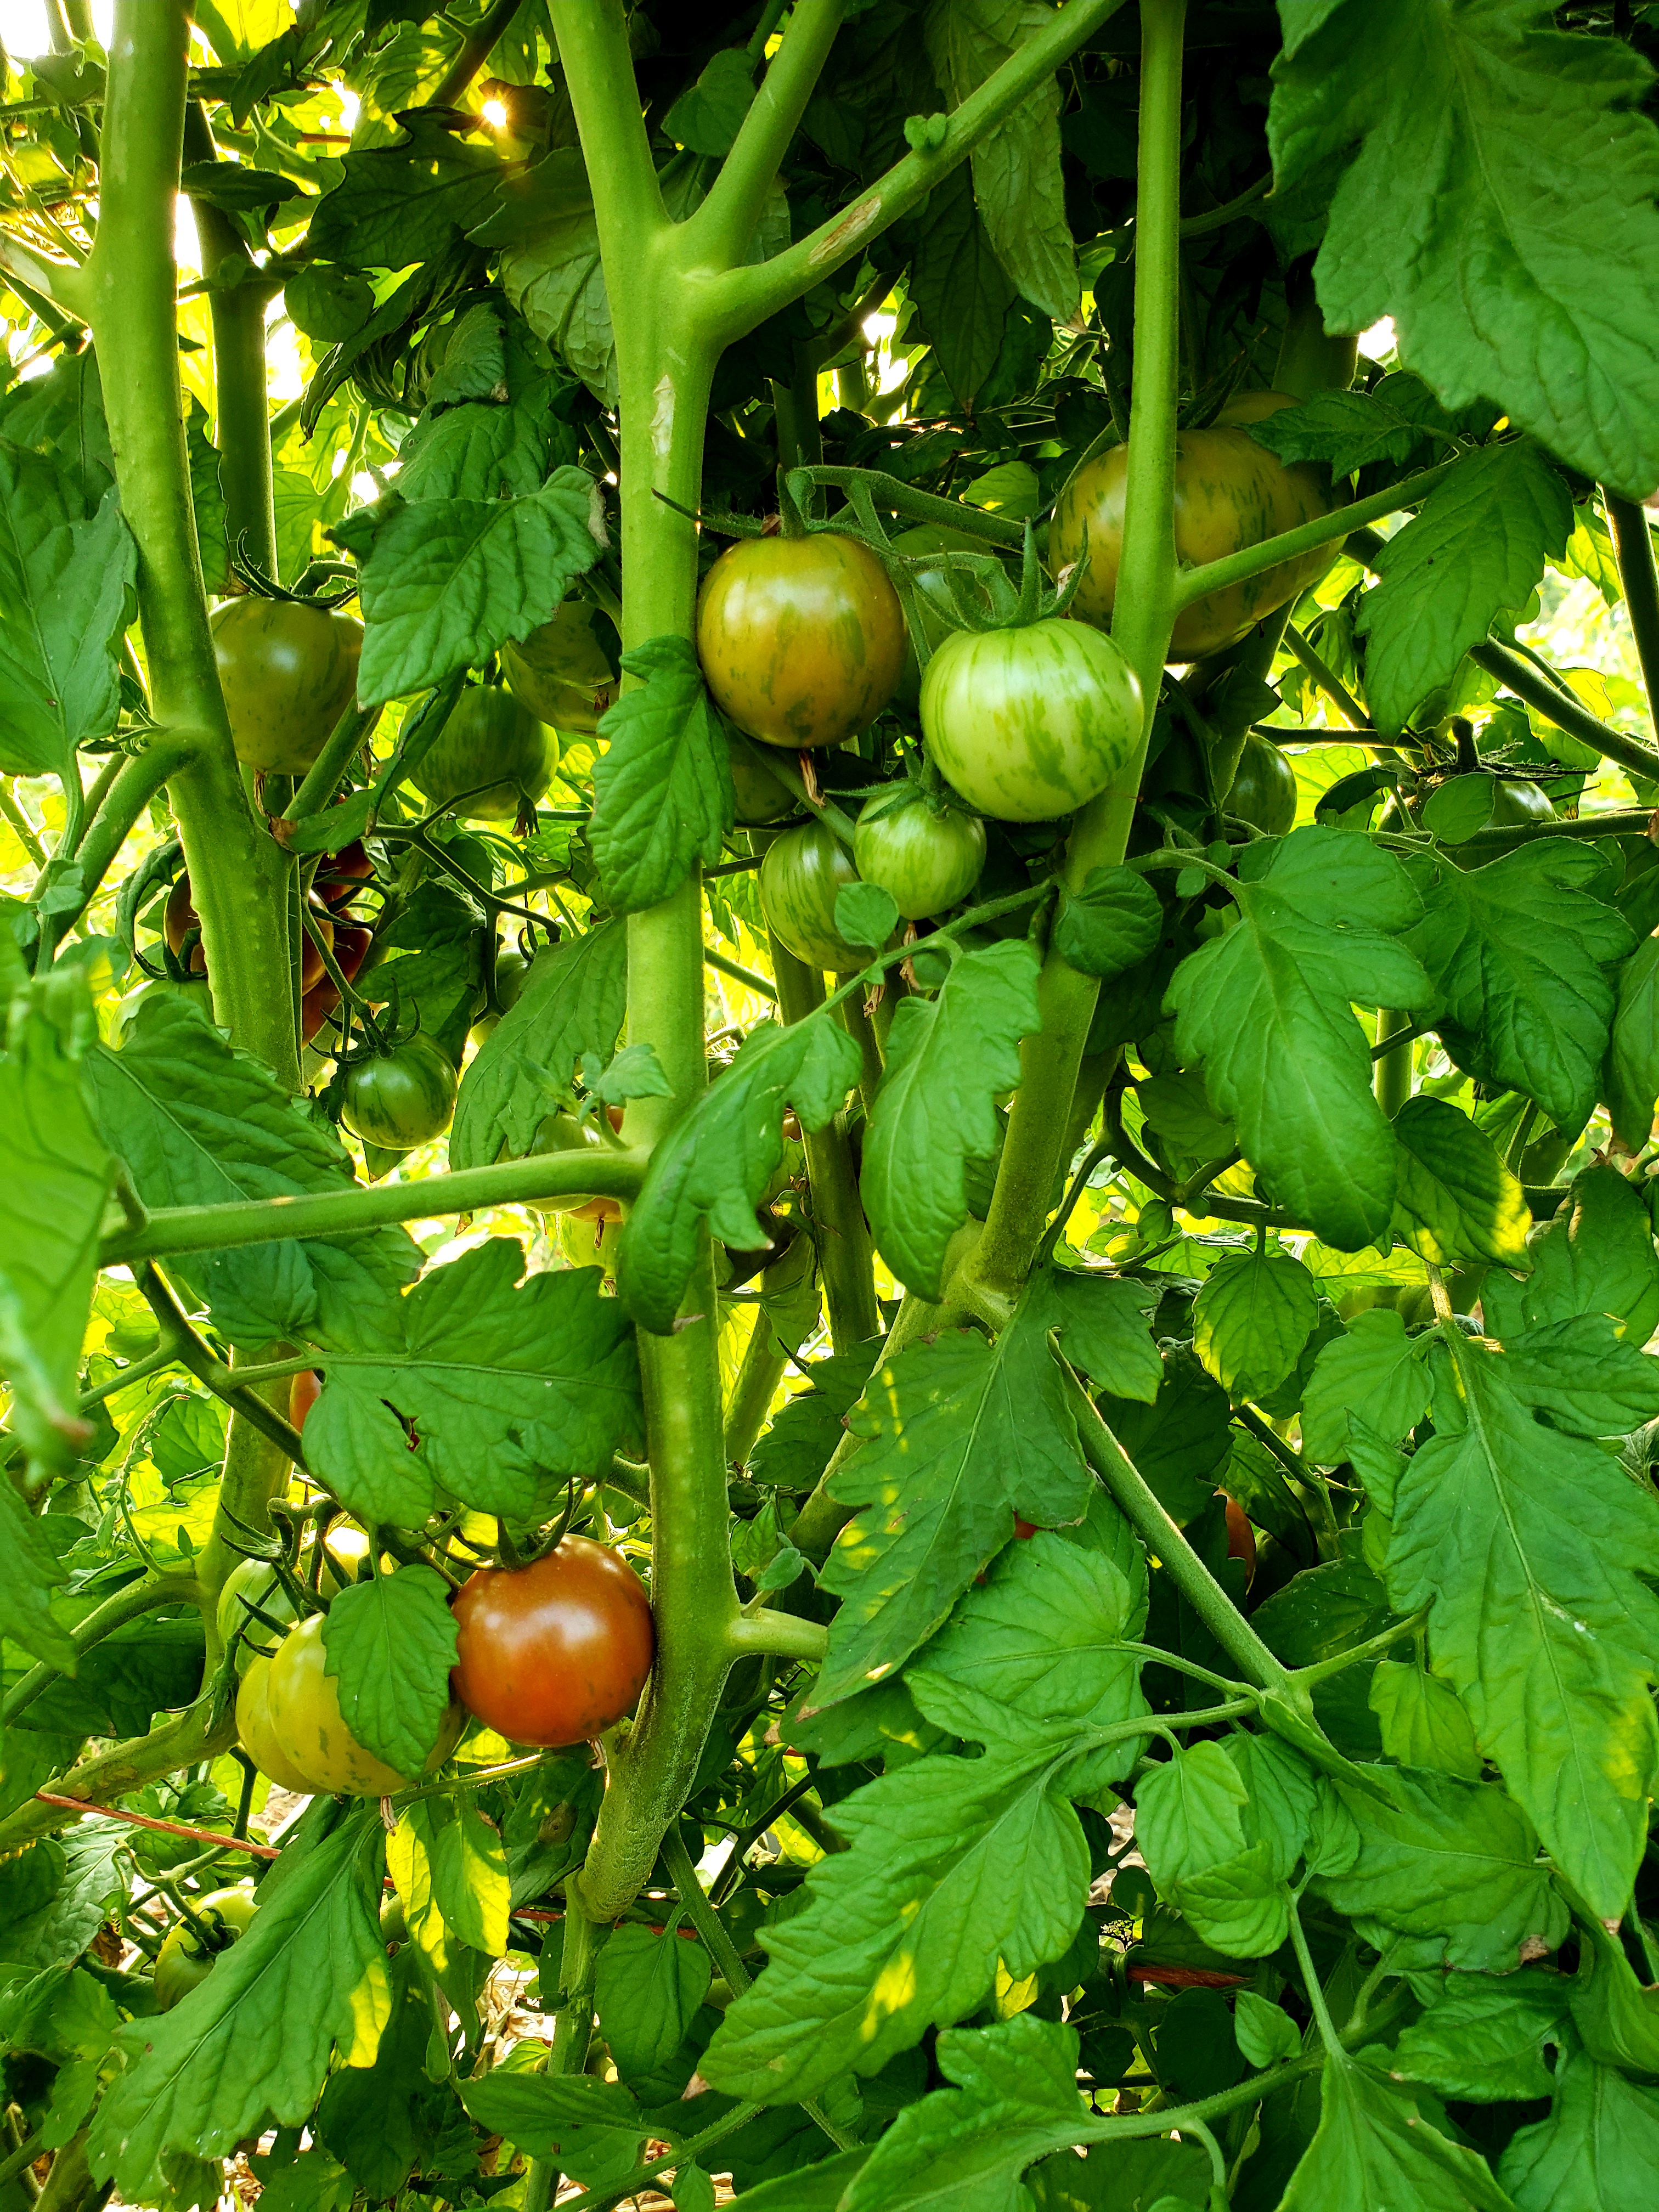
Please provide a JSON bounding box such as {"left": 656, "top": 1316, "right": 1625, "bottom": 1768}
{"left": 1314, "top": 1768, "right": 1568, "bottom": 1973}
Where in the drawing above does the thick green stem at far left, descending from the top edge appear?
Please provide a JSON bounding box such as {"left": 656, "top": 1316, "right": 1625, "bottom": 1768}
{"left": 80, "top": 0, "right": 298, "bottom": 1088}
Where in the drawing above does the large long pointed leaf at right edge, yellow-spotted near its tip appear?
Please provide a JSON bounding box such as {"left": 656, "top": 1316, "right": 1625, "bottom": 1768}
{"left": 1389, "top": 1323, "right": 1659, "bottom": 1918}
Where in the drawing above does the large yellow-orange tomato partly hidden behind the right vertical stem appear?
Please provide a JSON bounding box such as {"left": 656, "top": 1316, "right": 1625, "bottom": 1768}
{"left": 1048, "top": 392, "right": 1340, "bottom": 662}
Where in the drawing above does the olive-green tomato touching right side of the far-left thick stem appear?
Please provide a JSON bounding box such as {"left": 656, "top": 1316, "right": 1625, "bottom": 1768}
{"left": 210, "top": 597, "right": 363, "bottom": 776}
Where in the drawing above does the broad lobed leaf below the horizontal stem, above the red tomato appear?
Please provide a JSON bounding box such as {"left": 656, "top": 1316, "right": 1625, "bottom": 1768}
{"left": 305, "top": 1237, "right": 641, "bottom": 1528}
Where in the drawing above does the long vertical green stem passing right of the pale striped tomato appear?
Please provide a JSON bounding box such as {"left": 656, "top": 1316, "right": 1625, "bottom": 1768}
{"left": 958, "top": 0, "right": 1186, "bottom": 1296}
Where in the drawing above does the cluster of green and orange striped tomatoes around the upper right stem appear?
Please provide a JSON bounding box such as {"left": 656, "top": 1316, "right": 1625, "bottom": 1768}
{"left": 697, "top": 392, "right": 1336, "bottom": 971}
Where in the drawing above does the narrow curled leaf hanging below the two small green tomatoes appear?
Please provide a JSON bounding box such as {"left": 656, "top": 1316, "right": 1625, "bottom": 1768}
{"left": 860, "top": 938, "right": 1042, "bottom": 1299}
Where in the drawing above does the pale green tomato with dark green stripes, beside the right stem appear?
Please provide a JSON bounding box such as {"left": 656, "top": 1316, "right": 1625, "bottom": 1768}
{"left": 922, "top": 617, "right": 1142, "bottom": 823}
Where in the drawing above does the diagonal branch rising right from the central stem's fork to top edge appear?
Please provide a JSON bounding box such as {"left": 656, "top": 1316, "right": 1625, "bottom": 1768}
{"left": 695, "top": 0, "right": 1124, "bottom": 349}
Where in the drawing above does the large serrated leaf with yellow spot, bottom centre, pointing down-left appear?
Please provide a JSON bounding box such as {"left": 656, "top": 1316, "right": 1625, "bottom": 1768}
{"left": 701, "top": 1723, "right": 1088, "bottom": 2103}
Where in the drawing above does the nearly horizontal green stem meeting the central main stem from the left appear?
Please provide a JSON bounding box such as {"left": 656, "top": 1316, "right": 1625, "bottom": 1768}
{"left": 99, "top": 1148, "right": 646, "bottom": 1267}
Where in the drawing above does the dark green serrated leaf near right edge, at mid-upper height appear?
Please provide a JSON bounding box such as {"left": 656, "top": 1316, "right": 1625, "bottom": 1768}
{"left": 1407, "top": 838, "right": 1633, "bottom": 1130}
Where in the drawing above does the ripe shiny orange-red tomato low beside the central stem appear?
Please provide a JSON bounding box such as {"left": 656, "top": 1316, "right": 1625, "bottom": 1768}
{"left": 449, "top": 1535, "right": 654, "bottom": 1745}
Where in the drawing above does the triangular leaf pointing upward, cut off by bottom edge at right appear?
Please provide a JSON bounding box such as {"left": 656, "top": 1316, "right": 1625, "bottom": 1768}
{"left": 1278, "top": 2049, "right": 1515, "bottom": 2212}
